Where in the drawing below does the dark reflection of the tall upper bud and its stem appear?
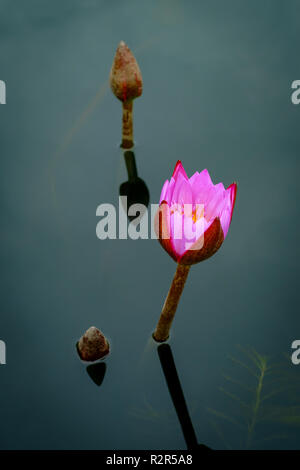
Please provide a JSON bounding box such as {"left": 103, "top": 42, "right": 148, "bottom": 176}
{"left": 119, "top": 150, "right": 150, "bottom": 221}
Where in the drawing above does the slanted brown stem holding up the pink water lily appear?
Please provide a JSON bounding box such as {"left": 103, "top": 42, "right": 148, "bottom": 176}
{"left": 153, "top": 264, "right": 190, "bottom": 343}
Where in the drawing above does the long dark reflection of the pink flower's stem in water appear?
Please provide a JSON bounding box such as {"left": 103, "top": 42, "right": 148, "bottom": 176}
{"left": 157, "top": 344, "right": 208, "bottom": 450}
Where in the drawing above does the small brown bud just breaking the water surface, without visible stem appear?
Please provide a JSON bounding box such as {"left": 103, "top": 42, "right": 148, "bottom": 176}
{"left": 77, "top": 326, "right": 109, "bottom": 361}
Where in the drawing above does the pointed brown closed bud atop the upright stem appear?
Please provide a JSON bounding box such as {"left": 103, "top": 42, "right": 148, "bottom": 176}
{"left": 110, "top": 41, "right": 143, "bottom": 102}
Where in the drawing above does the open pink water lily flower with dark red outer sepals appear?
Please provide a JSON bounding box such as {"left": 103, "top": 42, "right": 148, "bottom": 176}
{"left": 156, "top": 161, "right": 237, "bottom": 266}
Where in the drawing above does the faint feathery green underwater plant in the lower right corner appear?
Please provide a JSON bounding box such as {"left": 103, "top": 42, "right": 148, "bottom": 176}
{"left": 208, "top": 346, "right": 300, "bottom": 449}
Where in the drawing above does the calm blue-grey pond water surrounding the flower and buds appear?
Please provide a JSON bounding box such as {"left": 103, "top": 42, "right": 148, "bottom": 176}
{"left": 0, "top": 0, "right": 300, "bottom": 449}
